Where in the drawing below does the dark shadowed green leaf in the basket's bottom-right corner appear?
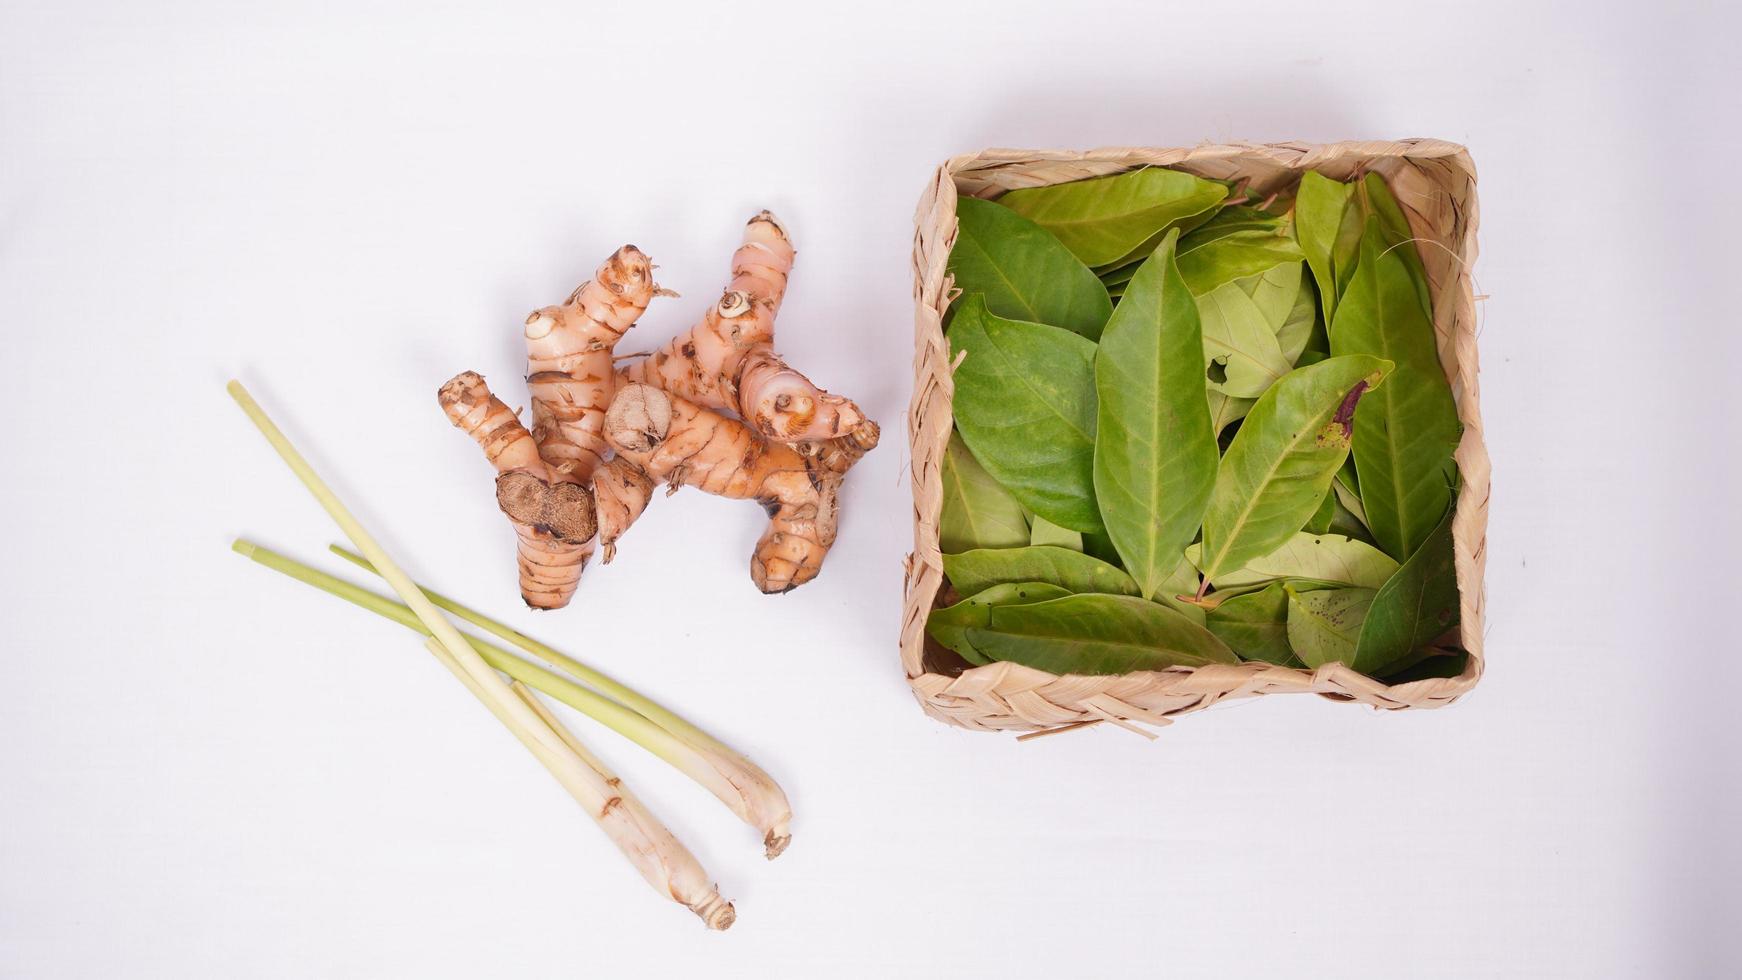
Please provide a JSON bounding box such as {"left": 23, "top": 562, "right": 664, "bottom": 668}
{"left": 1350, "top": 508, "right": 1458, "bottom": 675}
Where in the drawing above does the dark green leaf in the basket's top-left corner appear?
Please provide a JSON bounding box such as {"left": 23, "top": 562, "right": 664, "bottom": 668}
{"left": 949, "top": 197, "right": 1113, "bottom": 339}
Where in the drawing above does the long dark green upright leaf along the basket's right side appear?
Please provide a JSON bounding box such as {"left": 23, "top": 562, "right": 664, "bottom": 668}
{"left": 1331, "top": 219, "right": 1462, "bottom": 560}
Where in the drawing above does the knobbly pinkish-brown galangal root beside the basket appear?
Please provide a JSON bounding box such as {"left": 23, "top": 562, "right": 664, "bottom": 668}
{"left": 439, "top": 211, "right": 878, "bottom": 609}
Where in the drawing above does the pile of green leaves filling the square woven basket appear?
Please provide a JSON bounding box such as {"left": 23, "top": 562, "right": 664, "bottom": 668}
{"left": 927, "top": 167, "right": 1465, "bottom": 682}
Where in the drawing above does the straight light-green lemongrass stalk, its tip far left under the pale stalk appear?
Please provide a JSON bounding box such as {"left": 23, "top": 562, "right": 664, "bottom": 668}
{"left": 230, "top": 538, "right": 769, "bottom": 852}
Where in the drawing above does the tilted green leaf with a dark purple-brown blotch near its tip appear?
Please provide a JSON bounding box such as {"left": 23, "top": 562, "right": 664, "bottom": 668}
{"left": 1198, "top": 355, "right": 1392, "bottom": 581}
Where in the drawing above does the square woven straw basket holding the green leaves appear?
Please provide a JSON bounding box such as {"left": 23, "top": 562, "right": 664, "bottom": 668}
{"left": 901, "top": 139, "right": 1489, "bottom": 731}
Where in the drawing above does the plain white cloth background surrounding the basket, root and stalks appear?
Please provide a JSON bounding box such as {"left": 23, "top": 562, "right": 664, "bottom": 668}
{"left": 0, "top": 0, "right": 1742, "bottom": 978}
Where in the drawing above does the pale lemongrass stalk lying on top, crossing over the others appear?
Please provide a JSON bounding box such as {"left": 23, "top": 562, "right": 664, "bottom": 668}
{"left": 226, "top": 381, "right": 721, "bottom": 926}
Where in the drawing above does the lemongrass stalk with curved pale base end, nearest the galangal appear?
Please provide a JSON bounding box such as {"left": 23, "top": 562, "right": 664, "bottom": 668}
{"left": 330, "top": 545, "right": 793, "bottom": 860}
